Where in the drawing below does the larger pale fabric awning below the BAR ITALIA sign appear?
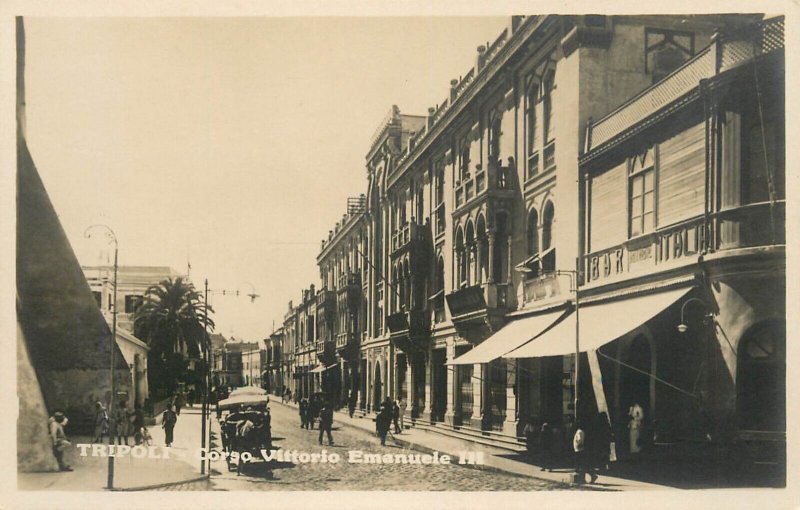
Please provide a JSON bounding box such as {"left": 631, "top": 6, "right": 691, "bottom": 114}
{"left": 501, "top": 288, "right": 691, "bottom": 358}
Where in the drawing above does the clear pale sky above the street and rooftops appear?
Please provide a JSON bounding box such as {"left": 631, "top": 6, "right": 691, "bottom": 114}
{"left": 25, "top": 17, "right": 507, "bottom": 340}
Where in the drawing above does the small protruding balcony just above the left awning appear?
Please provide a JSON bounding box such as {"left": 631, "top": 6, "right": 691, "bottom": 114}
{"left": 446, "top": 283, "right": 509, "bottom": 341}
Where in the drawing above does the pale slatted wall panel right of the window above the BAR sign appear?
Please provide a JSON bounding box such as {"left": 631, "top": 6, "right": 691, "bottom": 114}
{"left": 658, "top": 123, "right": 706, "bottom": 227}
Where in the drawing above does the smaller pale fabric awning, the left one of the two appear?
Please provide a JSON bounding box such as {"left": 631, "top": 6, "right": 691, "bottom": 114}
{"left": 447, "top": 310, "right": 569, "bottom": 365}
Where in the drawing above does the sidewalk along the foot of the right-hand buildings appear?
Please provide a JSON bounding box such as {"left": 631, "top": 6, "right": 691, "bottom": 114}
{"left": 271, "top": 400, "right": 660, "bottom": 491}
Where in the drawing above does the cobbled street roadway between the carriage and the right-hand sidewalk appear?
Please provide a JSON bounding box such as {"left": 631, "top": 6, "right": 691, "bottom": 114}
{"left": 193, "top": 405, "right": 562, "bottom": 491}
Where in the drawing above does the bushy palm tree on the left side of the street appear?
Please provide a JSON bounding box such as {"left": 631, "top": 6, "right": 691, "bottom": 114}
{"left": 134, "top": 277, "right": 214, "bottom": 392}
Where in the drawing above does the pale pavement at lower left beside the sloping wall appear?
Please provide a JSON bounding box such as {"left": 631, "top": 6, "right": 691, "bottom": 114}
{"left": 17, "top": 406, "right": 208, "bottom": 491}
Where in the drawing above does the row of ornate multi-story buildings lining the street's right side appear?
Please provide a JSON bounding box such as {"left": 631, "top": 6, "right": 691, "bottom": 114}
{"left": 268, "top": 15, "right": 785, "bottom": 474}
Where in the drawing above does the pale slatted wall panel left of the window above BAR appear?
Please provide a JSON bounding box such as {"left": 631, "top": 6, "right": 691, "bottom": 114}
{"left": 589, "top": 163, "right": 628, "bottom": 251}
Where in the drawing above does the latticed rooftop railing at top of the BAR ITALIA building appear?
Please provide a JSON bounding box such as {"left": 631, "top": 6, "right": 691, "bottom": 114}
{"left": 588, "top": 17, "right": 784, "bottom": 149}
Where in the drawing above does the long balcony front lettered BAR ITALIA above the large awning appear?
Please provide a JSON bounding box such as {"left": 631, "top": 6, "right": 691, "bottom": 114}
{"left": 582, "top": 200, "right": 786, "bottom": 285}
